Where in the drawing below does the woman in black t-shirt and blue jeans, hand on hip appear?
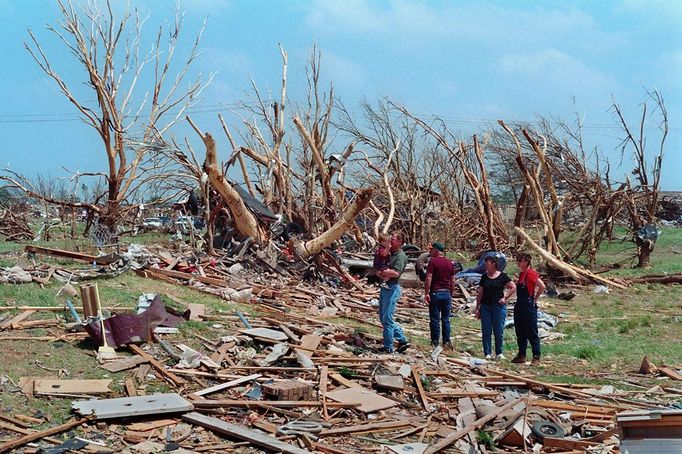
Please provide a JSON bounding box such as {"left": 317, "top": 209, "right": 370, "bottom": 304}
{"left": 476, "top": 256, "right": 516, "bottom": 359}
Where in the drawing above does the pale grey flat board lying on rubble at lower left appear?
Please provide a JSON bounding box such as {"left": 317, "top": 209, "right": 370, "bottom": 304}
{"left": 72, "top": 394, "right": 194, "bottom": 419}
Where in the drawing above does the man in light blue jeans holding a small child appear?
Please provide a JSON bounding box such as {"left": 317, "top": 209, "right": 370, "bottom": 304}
{"left": 377, "top": 232, "right": 410, "bottom": 353}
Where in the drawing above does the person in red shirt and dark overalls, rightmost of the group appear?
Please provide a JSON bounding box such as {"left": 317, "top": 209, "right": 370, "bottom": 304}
{"left": 511, "top": 252, "right": 545, "bottom": 364}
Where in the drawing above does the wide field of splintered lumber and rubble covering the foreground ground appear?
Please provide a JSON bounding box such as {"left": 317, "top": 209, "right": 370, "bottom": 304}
{"left": 0, "top": 243, "right": 682, "bottom": 454}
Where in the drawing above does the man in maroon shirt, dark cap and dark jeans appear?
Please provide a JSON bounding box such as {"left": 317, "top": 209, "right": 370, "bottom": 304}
{"left": 424, "top": 242, "right": 455, "bottom": 349}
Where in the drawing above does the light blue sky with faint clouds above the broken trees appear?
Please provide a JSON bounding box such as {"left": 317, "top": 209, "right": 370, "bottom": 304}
{"left": 0, "top": 0, "right": 682, "bottom": 190}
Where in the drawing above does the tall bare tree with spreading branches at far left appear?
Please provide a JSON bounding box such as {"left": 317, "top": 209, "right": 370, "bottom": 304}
{"left": 6, "top": 0, "right": 205, "bottom": 232}
